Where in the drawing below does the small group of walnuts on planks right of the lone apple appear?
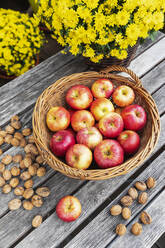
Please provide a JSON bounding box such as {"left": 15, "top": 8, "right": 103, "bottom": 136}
{"left": 110, "top": 177, "right": 156, "bottom": 236}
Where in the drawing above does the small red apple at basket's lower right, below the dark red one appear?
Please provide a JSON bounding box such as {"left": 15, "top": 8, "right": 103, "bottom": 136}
{"left": 117, "top": 130, "right": 140, "bottom": 154}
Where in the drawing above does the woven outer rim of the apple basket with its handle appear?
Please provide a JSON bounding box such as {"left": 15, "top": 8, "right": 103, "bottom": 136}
{"left": 32, "top": 66, "right": 160, "bottom": 180}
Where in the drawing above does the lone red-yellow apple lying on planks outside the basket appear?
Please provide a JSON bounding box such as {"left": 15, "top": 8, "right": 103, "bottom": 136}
{"left": 56, "top": 195, "right": 81, "bottom": 222}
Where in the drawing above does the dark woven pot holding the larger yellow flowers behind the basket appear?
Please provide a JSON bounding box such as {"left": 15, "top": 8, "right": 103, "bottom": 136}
{"left": 85, "top": 42, "right": 139, "bottom": 71}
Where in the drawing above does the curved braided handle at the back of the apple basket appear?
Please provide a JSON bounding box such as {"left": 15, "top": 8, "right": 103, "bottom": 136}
{"left": 99, "top": 65, "right": 142, "bottom": 87}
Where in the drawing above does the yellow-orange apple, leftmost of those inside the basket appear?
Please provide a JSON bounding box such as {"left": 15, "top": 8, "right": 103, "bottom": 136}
{"left": 46, "top": 106, "right": 70, "bottom": 132}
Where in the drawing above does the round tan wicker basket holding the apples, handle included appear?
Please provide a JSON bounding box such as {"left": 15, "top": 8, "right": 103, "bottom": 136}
{"left": 33, "top": 66, "right": 160, "bottom": 180}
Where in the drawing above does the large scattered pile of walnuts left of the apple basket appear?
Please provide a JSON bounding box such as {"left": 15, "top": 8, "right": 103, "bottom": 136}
{"left": 0, "top": 116, "right": 50, "bottom": 227}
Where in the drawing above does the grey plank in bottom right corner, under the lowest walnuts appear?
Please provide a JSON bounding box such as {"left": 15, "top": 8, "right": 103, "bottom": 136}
{"left": 107, "top": 191, "right": 165, "bottom": 248}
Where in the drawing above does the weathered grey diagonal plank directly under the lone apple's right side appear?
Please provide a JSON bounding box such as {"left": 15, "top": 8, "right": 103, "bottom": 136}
{"left": 14, "top": 119, "right": 165, "bottom": 248}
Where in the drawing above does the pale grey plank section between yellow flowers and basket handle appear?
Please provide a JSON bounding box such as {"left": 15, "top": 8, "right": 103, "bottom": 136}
{"left": 129, "top": 38, "right": 165, "bottom": 76}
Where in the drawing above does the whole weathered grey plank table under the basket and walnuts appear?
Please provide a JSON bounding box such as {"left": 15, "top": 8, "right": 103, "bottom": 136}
{"left": 0, "top": 33, "right": 165, "bottom": 248}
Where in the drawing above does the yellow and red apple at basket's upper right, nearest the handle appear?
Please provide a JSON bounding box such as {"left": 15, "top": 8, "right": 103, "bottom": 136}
{"left": 112, "top": 85, "right": 135, "bottom": 107}
